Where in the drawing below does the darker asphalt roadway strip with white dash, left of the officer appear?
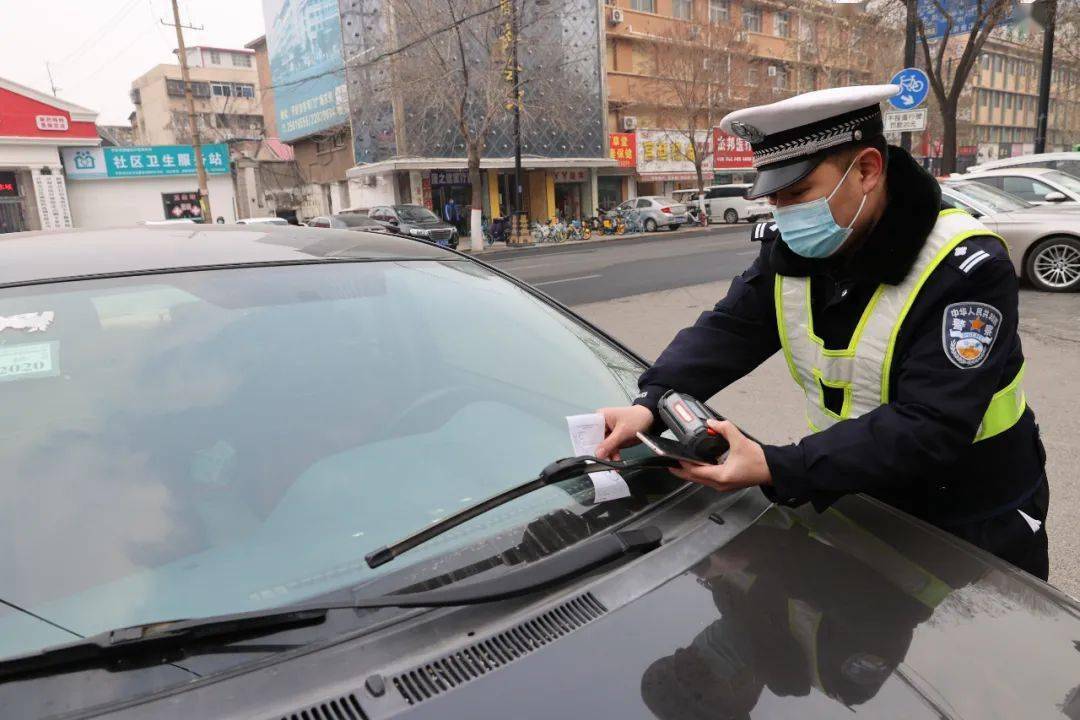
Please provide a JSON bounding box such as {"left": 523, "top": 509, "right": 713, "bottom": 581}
{"left": 489, "top": 222, "right": 758, "bottom": 304}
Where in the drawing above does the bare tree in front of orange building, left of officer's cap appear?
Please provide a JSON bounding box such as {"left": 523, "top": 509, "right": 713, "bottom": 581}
{"left": 650, "top": 13, "right": 748, "bottom": 214}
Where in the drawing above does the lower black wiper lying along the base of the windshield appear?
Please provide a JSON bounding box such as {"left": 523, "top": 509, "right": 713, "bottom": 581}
{"left": 0, "top": 527, "right": 661, "bottom": 683}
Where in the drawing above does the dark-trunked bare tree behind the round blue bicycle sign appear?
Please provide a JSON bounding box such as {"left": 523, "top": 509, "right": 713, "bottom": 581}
{"left": 918, "top": 0, "right": 1012, "bottom": 175}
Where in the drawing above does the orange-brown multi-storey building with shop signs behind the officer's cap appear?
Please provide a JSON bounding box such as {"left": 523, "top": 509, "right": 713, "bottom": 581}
{"left": 602, "top": 0, "right": 902, "bottom": 199}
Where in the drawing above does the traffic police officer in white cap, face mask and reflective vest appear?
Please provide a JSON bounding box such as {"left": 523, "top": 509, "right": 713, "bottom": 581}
{"left": 597, "top": 85, "right": 1050, "bottom": 579}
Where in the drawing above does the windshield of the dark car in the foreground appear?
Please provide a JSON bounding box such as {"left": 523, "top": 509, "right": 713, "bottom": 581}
{"left": 0, "top": 261, "right": 642, "bottom": 656}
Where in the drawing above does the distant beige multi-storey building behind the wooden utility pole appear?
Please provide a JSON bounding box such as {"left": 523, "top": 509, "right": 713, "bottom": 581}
{"left": 131, "top": 46, "right": 265, "bottom": 145}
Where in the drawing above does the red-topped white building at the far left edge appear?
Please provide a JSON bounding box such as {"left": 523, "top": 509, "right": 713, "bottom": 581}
{"left": 0, "top": 78, "right": 100, "bottom": 233}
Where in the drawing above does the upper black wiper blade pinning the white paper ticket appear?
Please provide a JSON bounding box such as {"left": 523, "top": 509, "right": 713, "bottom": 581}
{"left": 364, "top": 456, "right": 678, "bottom": 569}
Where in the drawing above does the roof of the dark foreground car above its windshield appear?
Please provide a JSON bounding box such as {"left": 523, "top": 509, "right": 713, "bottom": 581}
{"left": 0, "top": 225, "right": 457, "bottom": 287}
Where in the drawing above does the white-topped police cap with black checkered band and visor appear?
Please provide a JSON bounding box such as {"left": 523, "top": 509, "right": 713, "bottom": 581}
{"left": 720, "top": 85, "right": 900, "bottom": 199}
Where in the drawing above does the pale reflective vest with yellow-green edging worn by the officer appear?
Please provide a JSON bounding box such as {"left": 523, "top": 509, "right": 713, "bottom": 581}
{"left": 775, "top": 209, "right": 1026, "bottom": 441}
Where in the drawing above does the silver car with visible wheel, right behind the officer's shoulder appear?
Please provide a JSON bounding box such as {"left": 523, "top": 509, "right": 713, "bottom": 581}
{"left": 942, "top": 180, "right": 1080, "bottom": 293}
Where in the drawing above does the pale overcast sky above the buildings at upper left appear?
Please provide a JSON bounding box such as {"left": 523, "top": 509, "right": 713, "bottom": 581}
{"left": 0, "top": 0, "right": 264, "bottom": 124}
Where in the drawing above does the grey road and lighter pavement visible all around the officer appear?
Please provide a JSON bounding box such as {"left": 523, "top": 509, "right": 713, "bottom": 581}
{"left": 494, "top": 231, "right": 1080, "bottom": 598}
